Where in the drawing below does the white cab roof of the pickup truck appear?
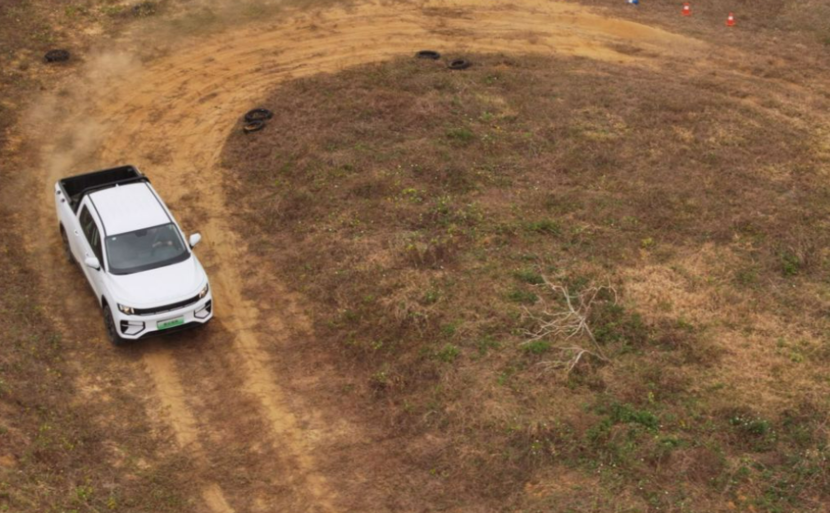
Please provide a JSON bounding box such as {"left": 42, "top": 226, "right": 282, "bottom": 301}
{"left": 88, "top": 182, "right": 172, "bottom": 237}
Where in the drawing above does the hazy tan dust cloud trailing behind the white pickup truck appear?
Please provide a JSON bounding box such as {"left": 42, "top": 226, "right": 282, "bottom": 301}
{"left": 29, "top": 0, "right": 296, "bottom": 182}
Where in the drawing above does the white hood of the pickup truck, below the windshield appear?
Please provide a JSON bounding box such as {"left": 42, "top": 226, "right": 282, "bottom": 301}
{"left": 108, "top": 254, "right": 207, "bottom": 308}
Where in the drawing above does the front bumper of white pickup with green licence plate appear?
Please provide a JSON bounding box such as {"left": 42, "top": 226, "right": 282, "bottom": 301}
{"left": 113, "top": 292, "right": 213, "bottom": 340}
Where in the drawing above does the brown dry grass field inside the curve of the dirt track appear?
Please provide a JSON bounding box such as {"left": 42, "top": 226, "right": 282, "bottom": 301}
{"left": 223, "top": 52, "right": 830, "bottom": 511}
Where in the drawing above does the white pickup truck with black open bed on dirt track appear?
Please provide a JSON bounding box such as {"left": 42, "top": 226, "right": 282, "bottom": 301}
{"left": 55, "top": 166, "right": 213, "bottom": 345}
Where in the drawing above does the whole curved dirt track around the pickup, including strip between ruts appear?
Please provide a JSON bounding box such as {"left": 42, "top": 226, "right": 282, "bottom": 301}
{"left": 24, "top": 0, "right": 705, "bottom": 512}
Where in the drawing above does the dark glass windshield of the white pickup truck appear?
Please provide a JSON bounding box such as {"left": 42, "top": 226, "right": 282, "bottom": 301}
{"left": 107, "top": 223, "right": 190, "bottom": 274}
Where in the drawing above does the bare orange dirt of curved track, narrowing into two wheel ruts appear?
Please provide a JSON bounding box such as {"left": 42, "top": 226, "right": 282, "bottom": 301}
{"left": 30, "top": 0, "right": 701, "bottom": 512}
